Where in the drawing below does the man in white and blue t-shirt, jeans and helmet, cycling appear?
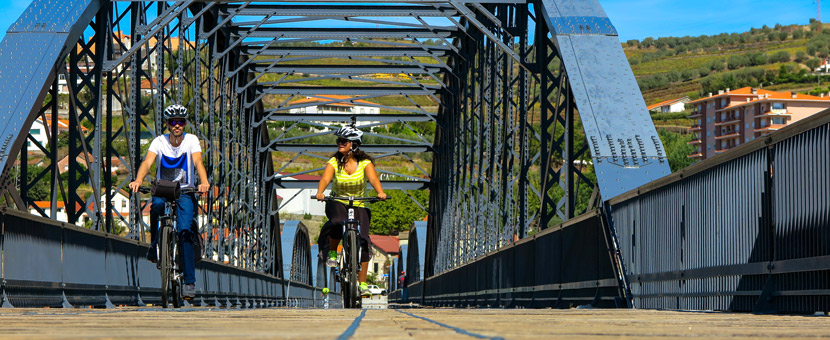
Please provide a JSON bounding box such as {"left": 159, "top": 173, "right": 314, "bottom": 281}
{"left": 130, "top": 104, "right": 210, "bottom": 298}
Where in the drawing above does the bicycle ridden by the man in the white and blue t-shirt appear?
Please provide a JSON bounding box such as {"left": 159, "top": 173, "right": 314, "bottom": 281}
{"left": 139, "top": 183, "right": 197, "bottom": 308}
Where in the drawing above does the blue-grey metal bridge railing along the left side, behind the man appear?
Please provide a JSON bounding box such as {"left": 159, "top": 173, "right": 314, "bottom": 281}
{"left": 0, "top": 209, "right": 332, "bottom": 308}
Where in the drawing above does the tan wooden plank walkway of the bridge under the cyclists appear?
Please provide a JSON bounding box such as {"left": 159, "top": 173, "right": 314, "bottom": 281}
{"left": 0, "top": 307, "right": 830, "bottom": 340}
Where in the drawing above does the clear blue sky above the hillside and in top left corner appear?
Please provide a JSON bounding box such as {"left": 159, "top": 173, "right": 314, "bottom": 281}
{"left": 0, "top": 0, "right": 830, "bottom": 41}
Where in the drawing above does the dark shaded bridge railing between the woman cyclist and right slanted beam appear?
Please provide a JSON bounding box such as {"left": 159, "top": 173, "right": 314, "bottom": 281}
{"left": 389, "top": 210, "right": 626, "bottom": 308}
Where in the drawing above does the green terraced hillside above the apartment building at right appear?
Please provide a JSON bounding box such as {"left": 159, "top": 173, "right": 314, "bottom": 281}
{"left": 623, "top": 22, "right": 830, "bottom": 104}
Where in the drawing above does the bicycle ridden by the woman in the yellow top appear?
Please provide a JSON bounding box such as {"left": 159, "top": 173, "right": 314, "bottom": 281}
{"left": 320, "top": 196, "right": 380, "bottom": 308}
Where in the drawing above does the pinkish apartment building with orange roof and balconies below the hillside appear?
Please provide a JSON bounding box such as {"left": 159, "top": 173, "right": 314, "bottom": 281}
{"left": 688, "top": 87, "right": 830, "bottom": 159}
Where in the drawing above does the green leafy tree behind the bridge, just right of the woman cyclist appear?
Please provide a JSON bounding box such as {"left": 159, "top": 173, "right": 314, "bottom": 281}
{"left": 369, "top": 190, "right": 429, "bottom": 235}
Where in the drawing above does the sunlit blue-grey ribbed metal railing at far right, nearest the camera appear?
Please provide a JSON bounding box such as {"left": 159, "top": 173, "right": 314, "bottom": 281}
{"left": 610, "top": 111, "right": 830, "bottom": 313}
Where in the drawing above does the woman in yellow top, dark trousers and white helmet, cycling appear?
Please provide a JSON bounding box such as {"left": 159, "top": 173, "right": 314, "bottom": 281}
{"left": 316, "top": 125, "right": 386, "bottom": 293}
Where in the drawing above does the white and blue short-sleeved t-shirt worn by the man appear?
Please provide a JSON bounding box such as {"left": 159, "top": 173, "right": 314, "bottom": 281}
{"left": 150, "top": 133, "right": 202, "bottom": 188}
